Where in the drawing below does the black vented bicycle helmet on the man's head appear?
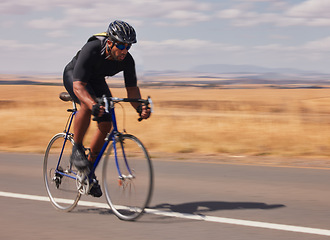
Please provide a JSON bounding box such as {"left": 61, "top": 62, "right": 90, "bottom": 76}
{"left": 107, "top": 20, "right": 137, "bottom": 44}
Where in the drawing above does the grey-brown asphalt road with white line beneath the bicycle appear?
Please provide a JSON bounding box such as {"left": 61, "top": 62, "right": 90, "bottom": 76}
{"left": 0, "top": 153, "right": 330, "bottom": 240}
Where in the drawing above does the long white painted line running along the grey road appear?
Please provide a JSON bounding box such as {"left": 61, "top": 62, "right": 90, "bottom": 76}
{"left": 0, "top": 191, "right": 330, "bottom": 236}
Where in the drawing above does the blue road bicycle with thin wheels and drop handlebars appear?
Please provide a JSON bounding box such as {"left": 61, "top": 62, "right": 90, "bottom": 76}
{"left": 43, "top": 93, "right": 153, "bottom": 221}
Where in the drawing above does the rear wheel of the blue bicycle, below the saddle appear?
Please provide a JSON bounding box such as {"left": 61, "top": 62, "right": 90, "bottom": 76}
{"left": 43, "top": 133, "right": 81, "bottom": 212}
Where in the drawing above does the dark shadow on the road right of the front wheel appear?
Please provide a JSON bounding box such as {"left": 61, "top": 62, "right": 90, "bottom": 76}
{"left": 150, "top": 201, "right": 285, "bottom": 214}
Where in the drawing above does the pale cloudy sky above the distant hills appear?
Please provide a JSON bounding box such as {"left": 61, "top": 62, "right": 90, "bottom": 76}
{"left": 0, "top": 0, "right": 330, "bottom": 74}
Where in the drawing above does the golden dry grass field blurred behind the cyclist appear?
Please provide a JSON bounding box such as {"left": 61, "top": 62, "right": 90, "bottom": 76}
{"left": 0, "top": 85, "right": 330, "bottom": 164}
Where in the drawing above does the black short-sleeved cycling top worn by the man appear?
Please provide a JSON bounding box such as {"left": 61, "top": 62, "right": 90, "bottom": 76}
{"left": 68, "top": 37, "right": 137, "bottom": 87}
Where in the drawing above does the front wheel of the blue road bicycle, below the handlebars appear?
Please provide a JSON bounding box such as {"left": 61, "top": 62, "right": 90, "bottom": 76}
{"left": 102, "top": 134, "right": 153, "bottom": 221}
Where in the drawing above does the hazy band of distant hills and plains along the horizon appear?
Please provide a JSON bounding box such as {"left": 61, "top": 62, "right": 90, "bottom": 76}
{"left": 0, "top": 64, "right": 330, "bottom": 88}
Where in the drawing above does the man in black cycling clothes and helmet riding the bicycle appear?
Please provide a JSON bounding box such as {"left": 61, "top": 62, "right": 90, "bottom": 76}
{"left": 63, "top": 20, "right": 150, "bottom": 197}
